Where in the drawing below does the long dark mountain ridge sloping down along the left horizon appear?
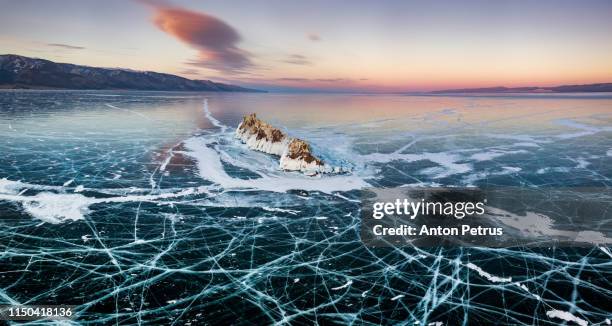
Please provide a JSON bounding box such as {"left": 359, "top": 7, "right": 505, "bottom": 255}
{"left": 0, "top": 54, "right": 259, "bottom": 92}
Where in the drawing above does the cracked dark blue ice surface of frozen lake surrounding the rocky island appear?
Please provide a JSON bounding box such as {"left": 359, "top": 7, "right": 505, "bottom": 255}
{"left": 0, "top": 91, "right": 612, "bottom": 325}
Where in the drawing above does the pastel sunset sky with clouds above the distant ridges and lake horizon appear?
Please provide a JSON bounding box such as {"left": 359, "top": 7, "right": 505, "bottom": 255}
{"left": 0, "top": 0, "right": 612, "bottom": 92}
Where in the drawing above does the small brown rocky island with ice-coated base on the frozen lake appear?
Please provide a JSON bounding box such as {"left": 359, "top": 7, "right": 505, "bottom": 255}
{"left": 236, "top": 113, "right": 346, "bottom": 175}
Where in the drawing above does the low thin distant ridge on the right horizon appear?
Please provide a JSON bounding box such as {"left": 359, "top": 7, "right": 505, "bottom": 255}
{"left": 431, "top": 83, "right": 612, "bottom": 94}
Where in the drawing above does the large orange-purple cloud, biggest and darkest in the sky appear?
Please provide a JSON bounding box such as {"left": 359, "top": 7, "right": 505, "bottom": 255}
{"left": 149, "top": 2, "right": 253, "bottom": 73}
